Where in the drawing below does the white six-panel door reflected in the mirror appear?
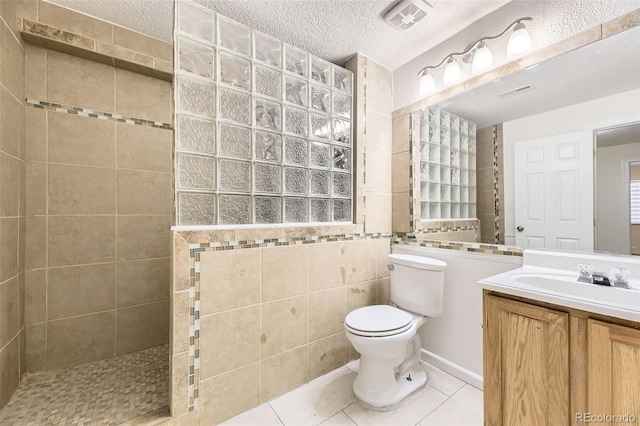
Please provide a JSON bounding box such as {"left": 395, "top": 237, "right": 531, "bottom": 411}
{"left": 514, "top": 130, "right": 593, "bottom": 251}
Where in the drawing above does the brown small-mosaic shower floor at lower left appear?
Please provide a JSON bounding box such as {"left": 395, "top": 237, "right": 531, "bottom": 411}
{"left": 0, "top": 345, "right": 169, "bottom": 426}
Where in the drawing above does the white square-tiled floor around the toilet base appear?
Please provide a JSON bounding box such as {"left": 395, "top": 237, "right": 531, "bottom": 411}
{"left": 223, "top": 361, "right": 483, "bottom": 426}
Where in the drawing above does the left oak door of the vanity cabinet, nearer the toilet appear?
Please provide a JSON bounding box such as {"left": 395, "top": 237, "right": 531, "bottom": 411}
{"left": 484, "top": 294, "right": 571, "bottom": 426}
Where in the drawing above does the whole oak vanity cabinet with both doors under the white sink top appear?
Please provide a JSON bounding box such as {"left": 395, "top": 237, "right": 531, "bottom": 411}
{"left": 483, "top": 290, "right": 640, "bottom": 426}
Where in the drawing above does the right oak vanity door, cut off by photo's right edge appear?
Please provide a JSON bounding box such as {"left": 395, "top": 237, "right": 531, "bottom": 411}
{"left": 587, "top": 320, "right": 640, "bottom": 424}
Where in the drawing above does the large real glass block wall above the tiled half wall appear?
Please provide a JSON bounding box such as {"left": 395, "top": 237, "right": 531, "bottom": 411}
{"left": 174, "top": 0, "right": 353, "bottom": 225}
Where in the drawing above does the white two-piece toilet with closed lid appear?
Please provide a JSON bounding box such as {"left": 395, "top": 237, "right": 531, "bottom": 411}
{"left": 344, "top": 254, "right": 447, "bottom": 411}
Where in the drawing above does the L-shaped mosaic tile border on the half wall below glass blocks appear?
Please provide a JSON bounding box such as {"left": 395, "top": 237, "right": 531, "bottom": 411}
{"left": 188, "top": 233, "right": 395, "bottom": 411}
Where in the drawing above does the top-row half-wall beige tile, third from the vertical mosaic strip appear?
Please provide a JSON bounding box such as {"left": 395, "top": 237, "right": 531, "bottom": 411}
{"left": 309, "top": 242, "right": 347, "bottom": 291}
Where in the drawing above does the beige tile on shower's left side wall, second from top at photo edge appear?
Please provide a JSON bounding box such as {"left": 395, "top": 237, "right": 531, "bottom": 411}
{"left": 0, "top": 20, "right": 24, "bottom": 100}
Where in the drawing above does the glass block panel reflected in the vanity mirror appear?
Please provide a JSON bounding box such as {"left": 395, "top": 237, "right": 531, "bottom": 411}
{"left": 420, "top": 107, "right": 476, "bottom": 220}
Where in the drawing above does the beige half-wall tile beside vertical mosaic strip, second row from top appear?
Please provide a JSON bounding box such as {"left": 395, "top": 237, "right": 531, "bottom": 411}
{"left": 200, "top": 305, "right": 260, "bottom": 378}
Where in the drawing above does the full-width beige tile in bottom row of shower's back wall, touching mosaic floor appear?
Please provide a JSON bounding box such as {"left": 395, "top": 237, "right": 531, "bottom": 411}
{"left": 47, "top": 311, "right": 116, "bottom": 370}
